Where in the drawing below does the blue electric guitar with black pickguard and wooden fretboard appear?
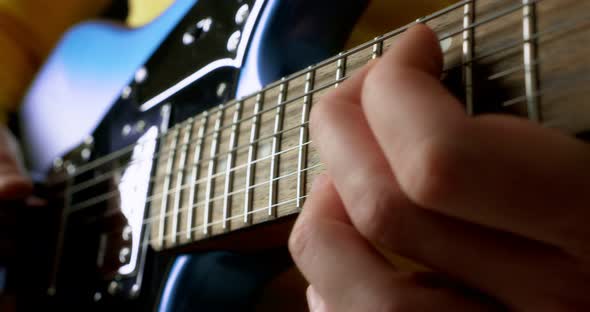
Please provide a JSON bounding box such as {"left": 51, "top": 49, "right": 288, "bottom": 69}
{"left": 13, "top": 0, "right": 590, "bottom": 310}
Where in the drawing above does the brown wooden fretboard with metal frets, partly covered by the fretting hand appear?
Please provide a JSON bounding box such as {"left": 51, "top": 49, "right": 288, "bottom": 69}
{"left": 144, "top": 0, "right": 590, "bottom": 250}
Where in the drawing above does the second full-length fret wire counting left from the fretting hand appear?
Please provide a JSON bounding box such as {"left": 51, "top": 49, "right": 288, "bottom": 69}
{"left": 268, "top": 78, "right": 287, "bottom": 218}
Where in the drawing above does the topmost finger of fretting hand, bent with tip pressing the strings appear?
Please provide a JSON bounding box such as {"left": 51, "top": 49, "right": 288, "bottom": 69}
{"left": 362, "top": 26, "right": 590, "bottom": 249}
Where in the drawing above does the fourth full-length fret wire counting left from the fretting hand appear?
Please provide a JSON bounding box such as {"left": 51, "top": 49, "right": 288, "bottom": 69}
{"left": 223, "top": 102, "right": 242, "bottom": 230}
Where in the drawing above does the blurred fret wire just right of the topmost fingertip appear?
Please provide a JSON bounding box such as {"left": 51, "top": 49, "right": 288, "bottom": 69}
{"left": 462, "top": 1, "right": 475, "bottom": 116}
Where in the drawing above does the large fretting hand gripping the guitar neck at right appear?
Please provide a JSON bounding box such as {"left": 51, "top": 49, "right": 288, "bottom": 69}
{"left": 289, "top": 26, "right": 590, "bottom": 311}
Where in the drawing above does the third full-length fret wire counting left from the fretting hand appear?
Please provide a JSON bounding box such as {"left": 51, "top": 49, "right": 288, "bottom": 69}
{"left": 243, "top": 93, "right": 264, "bottom": 224}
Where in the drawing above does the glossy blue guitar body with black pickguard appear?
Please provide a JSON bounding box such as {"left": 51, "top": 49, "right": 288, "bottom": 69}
{"left": 20, "top": 0, "right": 367, "bottom": 311}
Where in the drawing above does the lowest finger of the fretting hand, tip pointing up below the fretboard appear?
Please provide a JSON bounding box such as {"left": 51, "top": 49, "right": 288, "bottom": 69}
{"left": 289, "top": 179, "right": 500, "bottom": 311}
